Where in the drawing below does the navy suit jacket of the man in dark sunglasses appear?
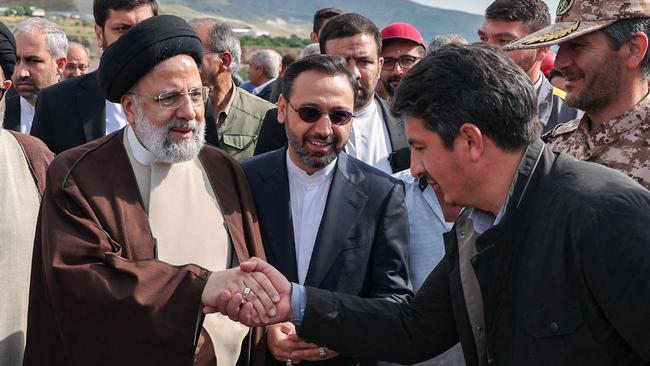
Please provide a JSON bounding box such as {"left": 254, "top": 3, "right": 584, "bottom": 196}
{"left": 242, "top": 149, "right": 413, "bottom": 365}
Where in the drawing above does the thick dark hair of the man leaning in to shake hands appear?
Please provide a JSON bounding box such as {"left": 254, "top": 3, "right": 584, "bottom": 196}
{"left": 392, "top": 43, "right": 541, "bottom": 151}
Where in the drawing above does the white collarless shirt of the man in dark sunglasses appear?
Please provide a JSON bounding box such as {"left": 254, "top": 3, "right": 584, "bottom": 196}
{"left": 287, "top": 149, "right": 336, "bottom": 285}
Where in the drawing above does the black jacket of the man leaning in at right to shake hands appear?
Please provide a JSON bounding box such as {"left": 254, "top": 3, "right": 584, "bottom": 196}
{"left": 298, "top": 141, "right": 650, "bottom": 366}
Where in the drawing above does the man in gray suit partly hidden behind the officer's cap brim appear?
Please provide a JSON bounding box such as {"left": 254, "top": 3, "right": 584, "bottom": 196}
{"left": 478, "top": 0, "right": 584, "bottom": 133}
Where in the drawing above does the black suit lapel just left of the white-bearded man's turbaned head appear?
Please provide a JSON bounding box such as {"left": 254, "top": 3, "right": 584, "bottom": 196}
{"left": 76, "top": 72, "right": 106, "bottom": 142}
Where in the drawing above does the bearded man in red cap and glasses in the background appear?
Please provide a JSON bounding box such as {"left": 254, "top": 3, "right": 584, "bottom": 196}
{"left": 376, "top": 22, "right": 426, "bottom": 100}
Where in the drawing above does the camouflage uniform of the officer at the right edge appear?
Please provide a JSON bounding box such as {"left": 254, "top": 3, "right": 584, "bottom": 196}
{"left": 545, "top": 95, "right": 650, "bottom": 189}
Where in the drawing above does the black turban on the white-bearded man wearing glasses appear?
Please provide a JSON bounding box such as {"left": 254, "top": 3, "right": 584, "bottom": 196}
{"left": 97, "top": 15, "right": 203, "bottom": 103}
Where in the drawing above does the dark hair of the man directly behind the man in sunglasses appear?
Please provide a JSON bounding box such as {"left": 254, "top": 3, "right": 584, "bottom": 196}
{"left": 318, "top": 13, "right": 381, "bottom": 56}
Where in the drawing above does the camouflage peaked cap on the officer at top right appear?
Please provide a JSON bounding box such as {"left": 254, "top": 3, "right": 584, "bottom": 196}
{"left": 504, "top": 0, "right": 650, "bottom": 51}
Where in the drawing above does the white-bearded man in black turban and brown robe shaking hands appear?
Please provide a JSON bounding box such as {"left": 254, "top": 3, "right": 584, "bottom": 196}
{"left": 24, "top": 15, "right": 275, "bottom": 366}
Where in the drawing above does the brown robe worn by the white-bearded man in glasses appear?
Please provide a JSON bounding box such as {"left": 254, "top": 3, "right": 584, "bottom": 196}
{"left": 24, "top": 130, "right": 264, "bottom": 365}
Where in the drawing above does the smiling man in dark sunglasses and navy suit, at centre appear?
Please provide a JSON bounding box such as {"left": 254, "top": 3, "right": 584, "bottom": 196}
{"left": 242, "top": 55, "right": 412, "bottom": 366}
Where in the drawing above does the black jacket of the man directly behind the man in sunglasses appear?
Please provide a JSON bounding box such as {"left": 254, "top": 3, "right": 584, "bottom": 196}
{"left": 255, "top": 94, "right": 411, "bottom": 173}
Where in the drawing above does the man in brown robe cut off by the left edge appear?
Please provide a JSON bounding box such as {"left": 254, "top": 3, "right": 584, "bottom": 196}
{"left": 0, "top": 23, "right": 53, "bottom": 366}
